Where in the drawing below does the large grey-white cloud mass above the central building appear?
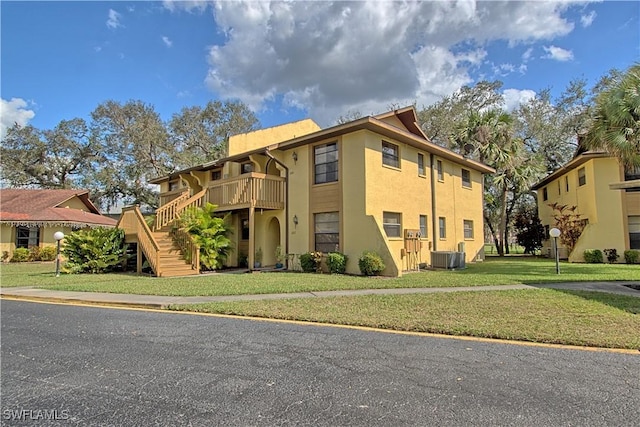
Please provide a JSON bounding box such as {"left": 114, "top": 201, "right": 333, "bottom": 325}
{"left": 163, "top": 1, "right": 596, "bottom": 125}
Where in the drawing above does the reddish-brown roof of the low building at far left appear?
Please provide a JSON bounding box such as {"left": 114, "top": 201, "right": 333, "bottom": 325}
{"left": 0, "top": 188, "right": 117, "bottom": 227}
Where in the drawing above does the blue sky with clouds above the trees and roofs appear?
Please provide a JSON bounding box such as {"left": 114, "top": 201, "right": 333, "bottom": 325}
{"left": 0, "top": 1, "right": 640, "bottom": 139}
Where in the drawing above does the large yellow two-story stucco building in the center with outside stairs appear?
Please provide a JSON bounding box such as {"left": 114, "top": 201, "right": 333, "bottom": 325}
{"left": 123, "top": 107, "right": 494, "bottom": 276}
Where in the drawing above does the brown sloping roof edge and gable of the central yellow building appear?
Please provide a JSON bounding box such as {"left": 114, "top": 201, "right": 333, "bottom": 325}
{"left": 149, "top": 107, "right": 495, "bottom": 184}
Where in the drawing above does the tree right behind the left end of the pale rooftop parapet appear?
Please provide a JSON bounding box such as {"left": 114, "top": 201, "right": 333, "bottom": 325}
{"left": 168, "top": 101, "right": 259, "bottom": 169}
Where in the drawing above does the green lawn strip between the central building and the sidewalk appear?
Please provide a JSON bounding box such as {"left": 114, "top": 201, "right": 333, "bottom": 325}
{"left": 0, "top": 257, "right": 640, "bottom": 296}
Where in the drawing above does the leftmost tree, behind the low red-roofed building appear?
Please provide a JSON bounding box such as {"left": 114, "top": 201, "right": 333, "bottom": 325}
{"left": 0, "top": 119, "right": 99, "bottom": 188}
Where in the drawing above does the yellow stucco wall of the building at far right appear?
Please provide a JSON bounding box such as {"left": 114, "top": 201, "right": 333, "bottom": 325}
{"left": 538, "top": 157, "right": 628, "bottom": 262}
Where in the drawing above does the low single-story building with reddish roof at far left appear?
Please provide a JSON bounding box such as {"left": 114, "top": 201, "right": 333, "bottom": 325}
{"left": 0, "top": 188, "right": 116, "bottom": 259}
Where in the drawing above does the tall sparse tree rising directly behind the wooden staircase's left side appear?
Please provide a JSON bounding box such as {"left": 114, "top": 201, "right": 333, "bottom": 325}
{"left": 85, "top": 101, "right": 176, "bottom": 208}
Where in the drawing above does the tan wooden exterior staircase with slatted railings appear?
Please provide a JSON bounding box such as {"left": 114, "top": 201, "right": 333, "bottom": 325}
{"left": 117, "top": 191, "right": 205, "bottom": 277}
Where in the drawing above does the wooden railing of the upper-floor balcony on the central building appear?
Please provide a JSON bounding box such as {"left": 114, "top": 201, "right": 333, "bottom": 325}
{"left": 206, "top": 172, "right": 285, "bottom": 210}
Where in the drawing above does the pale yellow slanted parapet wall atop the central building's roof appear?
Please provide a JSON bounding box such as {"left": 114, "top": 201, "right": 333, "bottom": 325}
{"left": 229, "top": 119, "right": 320, "bottom": 156}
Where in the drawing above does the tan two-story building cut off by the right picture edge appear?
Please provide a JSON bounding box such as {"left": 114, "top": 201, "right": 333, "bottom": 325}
{"left": 533, "top": 151, "right": 640, "bottom": 262}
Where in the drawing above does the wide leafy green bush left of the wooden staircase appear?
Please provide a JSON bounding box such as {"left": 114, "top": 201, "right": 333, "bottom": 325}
{"left": 62, "top": 228, "right": 127, "bottom": 273}
